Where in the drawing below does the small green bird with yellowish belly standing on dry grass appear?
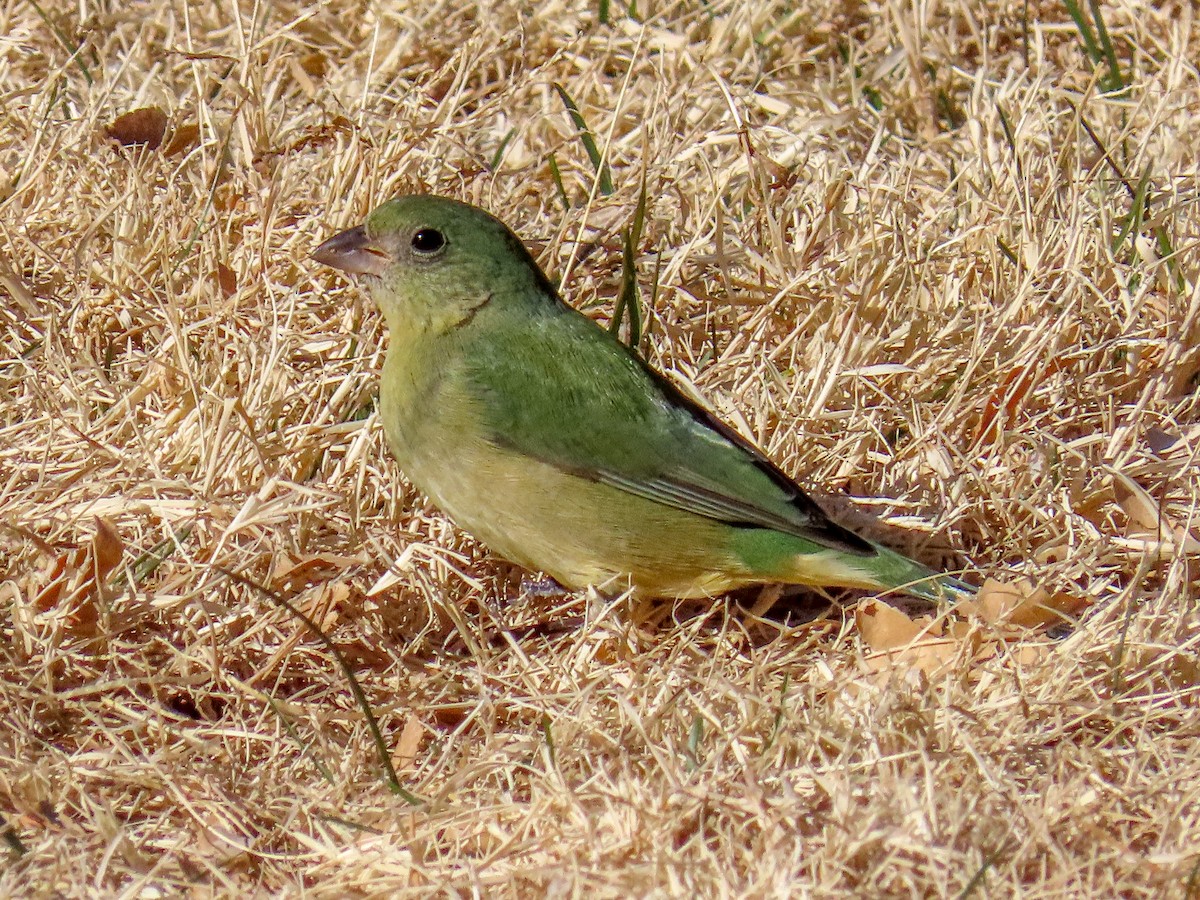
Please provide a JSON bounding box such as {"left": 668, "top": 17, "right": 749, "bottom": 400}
{"left": 313, "top": 196, "right": 972, "bottom": 607}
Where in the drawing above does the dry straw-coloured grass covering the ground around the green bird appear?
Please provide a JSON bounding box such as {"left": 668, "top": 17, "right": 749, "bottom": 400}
{"left": 0, "top": 0, "right": 1200, "bottom": 896}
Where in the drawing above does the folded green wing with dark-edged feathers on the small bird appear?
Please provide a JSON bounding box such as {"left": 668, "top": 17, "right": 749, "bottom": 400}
{"left": 468, "top": 306, "right": 875, "bottom": 556}
